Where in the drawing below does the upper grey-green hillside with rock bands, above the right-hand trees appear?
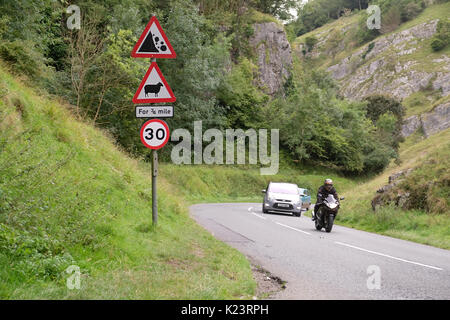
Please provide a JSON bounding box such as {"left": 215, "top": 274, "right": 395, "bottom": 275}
{"left": 293, "top": 2, "right": 450, "bottom": 129}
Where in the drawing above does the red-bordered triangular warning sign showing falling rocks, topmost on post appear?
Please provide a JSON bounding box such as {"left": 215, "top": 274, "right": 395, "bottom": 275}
{"left": 131, "top": 16, "right": 177, "bottom": 58}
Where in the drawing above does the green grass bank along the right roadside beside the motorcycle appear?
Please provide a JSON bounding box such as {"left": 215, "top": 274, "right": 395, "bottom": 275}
{"left": 336, "top": 129, "right": 450, "bottom": 249}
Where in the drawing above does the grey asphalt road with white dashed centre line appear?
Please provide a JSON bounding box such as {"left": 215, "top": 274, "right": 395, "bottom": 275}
{"left": 190, "top": 203, "right": 450, "bottom": 300}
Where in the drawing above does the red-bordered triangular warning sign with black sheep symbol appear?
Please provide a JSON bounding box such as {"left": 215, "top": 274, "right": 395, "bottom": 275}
{"left": 133, "top": 62, "right": 177, "bottom": 104}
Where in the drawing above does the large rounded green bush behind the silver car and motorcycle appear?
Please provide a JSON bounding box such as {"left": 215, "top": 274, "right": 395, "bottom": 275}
{"left": 264, "top": 70, "right": 396, "bottom": 174}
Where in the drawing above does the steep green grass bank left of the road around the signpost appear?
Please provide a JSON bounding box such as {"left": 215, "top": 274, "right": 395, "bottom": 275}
{"left": 0, "top": 67, "right": 256, "bottom": 299}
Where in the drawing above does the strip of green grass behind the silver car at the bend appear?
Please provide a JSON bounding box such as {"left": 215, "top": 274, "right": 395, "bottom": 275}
{"left": 161, "top": 164, "right": 358, "bottom": 203}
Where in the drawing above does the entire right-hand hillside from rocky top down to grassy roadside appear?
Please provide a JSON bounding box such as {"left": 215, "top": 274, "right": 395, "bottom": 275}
{"left": 292, "top": 2, "right": 450, "bottom": 249}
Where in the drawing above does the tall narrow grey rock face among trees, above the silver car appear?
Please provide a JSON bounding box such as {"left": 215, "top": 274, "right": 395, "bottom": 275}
{"left": 250, "top": 22, "right": 292, "bottom": 95}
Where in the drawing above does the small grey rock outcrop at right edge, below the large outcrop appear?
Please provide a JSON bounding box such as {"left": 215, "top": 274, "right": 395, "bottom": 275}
{"left": 401, "top": 102, "right": 450, "bottom": 138}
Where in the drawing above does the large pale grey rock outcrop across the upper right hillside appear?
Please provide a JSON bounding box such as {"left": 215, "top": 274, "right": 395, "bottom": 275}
{"left": 328, "top": 20, "right": 450, "bottom": 99}
